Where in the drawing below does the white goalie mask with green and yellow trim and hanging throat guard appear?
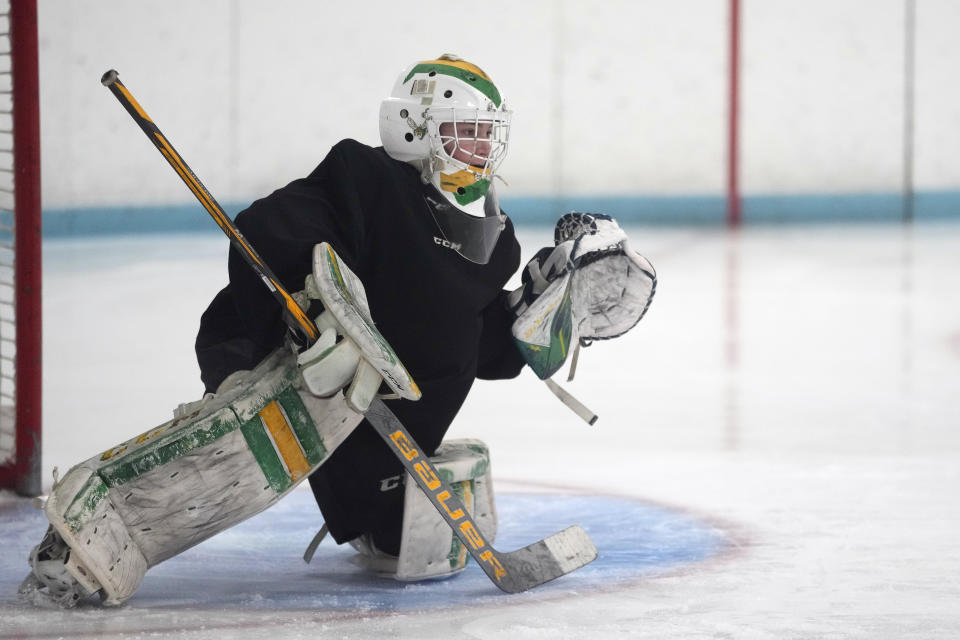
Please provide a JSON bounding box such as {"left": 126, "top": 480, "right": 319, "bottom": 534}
{"left": 380, "top": 54, "right": 511, "bottom": 264}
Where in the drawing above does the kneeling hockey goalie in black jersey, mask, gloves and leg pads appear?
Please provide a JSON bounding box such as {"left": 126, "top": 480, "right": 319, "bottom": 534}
{"left": 21, "top": 55, "right": 656, "bottom": 607}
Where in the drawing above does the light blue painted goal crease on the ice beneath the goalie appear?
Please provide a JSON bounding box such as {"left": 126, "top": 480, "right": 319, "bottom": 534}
{"left": 0, "top": 490, "right": 728, "bottom": 611}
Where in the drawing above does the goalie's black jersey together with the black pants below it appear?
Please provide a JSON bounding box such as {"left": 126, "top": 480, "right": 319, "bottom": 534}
{"left": 196, "top": 140, "right": 523, "bottom": 553}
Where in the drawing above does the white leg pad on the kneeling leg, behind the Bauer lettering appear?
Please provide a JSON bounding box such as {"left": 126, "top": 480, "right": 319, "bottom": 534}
{"left": 351, "top": 439, "right": 497, "bottom": 581}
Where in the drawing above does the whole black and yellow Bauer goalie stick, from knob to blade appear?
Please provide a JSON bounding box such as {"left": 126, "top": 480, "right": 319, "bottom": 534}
{"left": 100, "top": 69, "right": 597, "bottom": 593}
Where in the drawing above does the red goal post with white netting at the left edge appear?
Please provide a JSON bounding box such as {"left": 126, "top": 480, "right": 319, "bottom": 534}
{"left": 0, "top": 0, "right": 41, "bottom": 496}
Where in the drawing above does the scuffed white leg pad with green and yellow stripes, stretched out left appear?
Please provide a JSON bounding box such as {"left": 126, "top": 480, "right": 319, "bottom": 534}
{"left": 34, "top": 348, "right": 363, "bottom": 604}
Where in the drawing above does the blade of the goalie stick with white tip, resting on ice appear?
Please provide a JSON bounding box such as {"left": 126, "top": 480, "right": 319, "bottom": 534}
{"left": 497, "top": 525, "right": 597, "bottom": 593}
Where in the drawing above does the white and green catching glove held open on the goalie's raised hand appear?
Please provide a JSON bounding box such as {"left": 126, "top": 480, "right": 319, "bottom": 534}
{"left": 508, "top": 213, "right": 657, "bottom": 380}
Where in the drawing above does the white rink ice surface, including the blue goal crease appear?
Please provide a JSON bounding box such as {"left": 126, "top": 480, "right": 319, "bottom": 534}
{"left": 0, "top": 224, "right": 960, "bottom": 640}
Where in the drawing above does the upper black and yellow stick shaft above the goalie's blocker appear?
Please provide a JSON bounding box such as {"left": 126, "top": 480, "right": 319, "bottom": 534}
{"left": 100, "top": 69, "right": 320, "bottom": 345}
